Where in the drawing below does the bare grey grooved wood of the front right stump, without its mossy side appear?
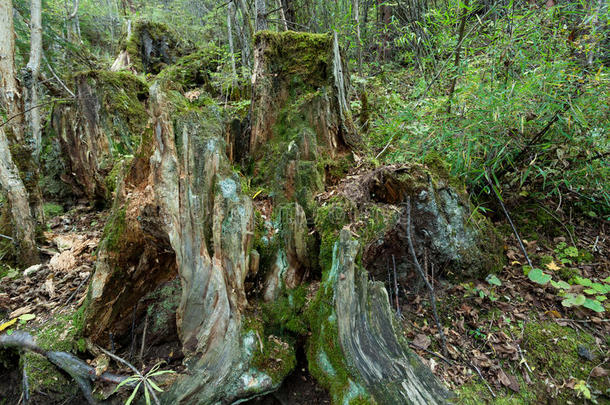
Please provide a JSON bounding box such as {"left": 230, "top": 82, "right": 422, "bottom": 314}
{"left": 327, "top": 230, "right": 450, "bottom": 405}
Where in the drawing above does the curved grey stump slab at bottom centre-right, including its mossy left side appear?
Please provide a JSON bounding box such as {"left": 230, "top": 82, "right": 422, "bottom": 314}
{"left": 308, "top": 230, "right": 449, "bottom": 405}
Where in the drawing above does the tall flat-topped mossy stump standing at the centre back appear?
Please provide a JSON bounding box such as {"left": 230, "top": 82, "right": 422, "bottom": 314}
{"left": 249, "top": 31, "right": 359, "bottom": 216}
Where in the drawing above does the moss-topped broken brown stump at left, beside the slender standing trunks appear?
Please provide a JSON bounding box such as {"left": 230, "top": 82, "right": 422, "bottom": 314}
{"left": 52, "top": 71, "right": 148, "bottom": 201}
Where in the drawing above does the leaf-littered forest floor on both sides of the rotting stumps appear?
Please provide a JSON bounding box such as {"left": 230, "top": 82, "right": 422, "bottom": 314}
{"left": 0, "top": 195, "right": 610, "bottom": 405}
